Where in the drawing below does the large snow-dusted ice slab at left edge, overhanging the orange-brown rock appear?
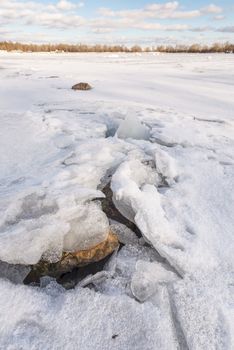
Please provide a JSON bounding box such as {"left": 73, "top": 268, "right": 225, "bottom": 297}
{"left": 0, "top": 191, "right": 109, "bottom": 264}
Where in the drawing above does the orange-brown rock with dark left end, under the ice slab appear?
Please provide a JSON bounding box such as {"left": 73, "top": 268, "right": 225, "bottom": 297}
{"left": 24, "top": 231, "right": 119, "bottom": 284}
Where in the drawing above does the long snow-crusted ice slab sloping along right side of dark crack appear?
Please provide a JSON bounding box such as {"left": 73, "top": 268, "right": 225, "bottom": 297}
{"left": 111, "top": 160, "right": 178, "bottom": 248}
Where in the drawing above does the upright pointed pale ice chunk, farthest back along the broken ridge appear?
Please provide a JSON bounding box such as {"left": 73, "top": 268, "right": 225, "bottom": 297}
{"left": 116, "top": 115, "right": 150, "bottom": 140}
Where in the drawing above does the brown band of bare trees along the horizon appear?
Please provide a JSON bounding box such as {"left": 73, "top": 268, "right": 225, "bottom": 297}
{"left": 0, "top": 41, "right": 234, "bottom": 53}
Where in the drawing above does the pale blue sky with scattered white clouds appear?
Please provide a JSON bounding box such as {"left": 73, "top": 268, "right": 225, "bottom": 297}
{"left": 0, "top": 0, "right": 234, "bottom": 46}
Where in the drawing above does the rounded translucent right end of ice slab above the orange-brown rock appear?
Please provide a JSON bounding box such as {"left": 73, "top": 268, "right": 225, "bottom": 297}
{"left": 64, "top": 202, "right": 109, "bottom": 252}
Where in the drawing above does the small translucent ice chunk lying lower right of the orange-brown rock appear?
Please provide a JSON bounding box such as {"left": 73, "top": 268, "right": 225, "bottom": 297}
{"left": 131, "top": 260, "right": 178, "bottom": 302}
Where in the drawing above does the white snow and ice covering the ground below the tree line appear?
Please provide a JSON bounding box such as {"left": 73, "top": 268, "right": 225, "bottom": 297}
{"left": 0, "top": 52, "right": 234, "bottom": 350}
